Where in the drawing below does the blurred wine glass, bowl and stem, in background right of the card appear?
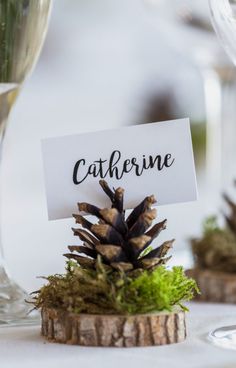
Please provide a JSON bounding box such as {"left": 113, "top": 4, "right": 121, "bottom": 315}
{"left": 144, "top": 0, "right": 235, "bottom": 212}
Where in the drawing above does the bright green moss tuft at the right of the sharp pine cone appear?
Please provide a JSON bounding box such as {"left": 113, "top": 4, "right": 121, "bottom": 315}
{"left": 113, "top": 266, "right": 198, "bottom": 314}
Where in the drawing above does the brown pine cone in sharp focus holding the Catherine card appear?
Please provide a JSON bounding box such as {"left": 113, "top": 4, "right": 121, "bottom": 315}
{"left": 65, "top": 180, "right": 174, "bottom": 272}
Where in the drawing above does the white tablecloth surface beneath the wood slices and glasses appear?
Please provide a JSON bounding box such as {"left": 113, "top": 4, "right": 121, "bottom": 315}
{"left": 0, "top": 303, "right": 236, "bottom": 368}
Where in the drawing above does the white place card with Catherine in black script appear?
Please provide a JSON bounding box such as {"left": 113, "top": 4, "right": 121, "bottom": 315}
{"left": 42, "top": 119, "right": 197, "bottom": 220}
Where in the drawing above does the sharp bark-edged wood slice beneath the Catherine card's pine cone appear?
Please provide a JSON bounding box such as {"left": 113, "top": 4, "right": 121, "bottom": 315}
{"left": 41, "top": 308, "right": 186, "bottom": 347}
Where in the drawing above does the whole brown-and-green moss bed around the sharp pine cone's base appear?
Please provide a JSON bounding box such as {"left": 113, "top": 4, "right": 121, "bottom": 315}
{"left": 34, "top": 258, "right": 198, "bottom": 314}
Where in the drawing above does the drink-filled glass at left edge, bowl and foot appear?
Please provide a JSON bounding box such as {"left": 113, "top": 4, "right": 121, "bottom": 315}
{"left": 0, "top": 0, "right": 52, "bottom": 326}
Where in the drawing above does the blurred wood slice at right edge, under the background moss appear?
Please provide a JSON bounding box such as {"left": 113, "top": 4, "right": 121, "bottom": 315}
{"left": 186, "top": 268, "right": 236, "bottom": 304}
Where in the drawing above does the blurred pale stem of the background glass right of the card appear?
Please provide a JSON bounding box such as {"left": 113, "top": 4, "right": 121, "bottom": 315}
{"left": 202, "top": 67, "right": 235, "bottom": 213}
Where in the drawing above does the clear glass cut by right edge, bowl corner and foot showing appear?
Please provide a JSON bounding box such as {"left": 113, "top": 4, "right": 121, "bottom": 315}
{"left": 209, "top": 0, "right": 236, "bottom": 350}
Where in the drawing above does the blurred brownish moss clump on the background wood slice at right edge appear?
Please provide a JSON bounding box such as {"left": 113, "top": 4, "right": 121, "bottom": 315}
{"left": 192, "top": 217, "right": 236, "bottom": 273}
